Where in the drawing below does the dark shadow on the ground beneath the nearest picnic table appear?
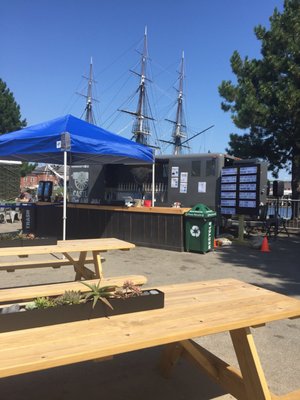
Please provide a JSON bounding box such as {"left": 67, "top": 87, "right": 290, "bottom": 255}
{"left": 0, "top": 347, "right": 223, "bottom": 400}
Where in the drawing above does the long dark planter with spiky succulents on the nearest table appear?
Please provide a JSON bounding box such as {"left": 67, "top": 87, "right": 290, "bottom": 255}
{"left": 0, "top": 281, "right": 164, "bottom": 332}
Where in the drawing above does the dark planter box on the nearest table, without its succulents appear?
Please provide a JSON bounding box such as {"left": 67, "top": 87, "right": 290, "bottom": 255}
{"left": 0, "top": 289, "right": 164, "bottom": 332}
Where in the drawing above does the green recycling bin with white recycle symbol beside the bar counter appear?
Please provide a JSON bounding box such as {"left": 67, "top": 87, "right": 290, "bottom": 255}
{"left": 185, "top": 203, "right": 217, "bottom": 253}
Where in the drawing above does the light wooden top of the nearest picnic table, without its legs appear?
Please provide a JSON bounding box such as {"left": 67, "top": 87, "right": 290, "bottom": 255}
{"left": 0, "top": 279, "right": 300, "bottom": 377}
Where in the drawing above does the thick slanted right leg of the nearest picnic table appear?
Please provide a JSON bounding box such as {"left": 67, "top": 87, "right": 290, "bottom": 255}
{"left": 230, "top": 328, "right": 272, "bottom": 400}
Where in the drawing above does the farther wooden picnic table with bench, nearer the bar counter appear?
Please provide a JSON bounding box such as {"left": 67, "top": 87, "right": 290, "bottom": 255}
{"left": 0, "top": 238, "right": 135, "bottom": 280}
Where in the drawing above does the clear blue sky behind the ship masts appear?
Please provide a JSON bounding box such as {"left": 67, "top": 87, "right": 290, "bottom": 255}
{"left": 0, "top": 0, "right": 283, "bottom": 177}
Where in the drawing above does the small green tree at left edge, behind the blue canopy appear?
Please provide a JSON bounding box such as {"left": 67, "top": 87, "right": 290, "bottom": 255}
{"left": 0, "top": 78, "right": 26, "bottom": 134}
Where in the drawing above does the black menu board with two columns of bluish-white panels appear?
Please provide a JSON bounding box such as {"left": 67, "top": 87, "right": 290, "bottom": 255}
{"left": 220, "top": 164, "right": 260, "bottom": 215}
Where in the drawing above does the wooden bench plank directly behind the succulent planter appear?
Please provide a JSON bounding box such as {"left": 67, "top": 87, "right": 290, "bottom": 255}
{"left": 0, "top": 275, "right": 147, "bottom": 307}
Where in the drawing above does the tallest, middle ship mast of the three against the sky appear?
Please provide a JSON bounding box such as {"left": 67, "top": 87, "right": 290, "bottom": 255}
{"left": 120, "top": 27, "right": 153, "bottom": 145}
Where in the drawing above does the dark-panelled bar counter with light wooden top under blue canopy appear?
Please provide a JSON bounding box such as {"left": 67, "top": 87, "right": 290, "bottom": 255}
{"left": 36, "top": 202, "right": 189, "bottom": 251}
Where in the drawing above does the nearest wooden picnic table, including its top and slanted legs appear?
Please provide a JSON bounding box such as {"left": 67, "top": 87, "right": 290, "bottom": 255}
{"left": 0, "top": 279, "right": 300, "bottom": 400}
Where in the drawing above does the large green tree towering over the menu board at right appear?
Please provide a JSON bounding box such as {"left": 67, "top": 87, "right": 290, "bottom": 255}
{"left": 219, "top": 0, "right": 300, "bottom": 199}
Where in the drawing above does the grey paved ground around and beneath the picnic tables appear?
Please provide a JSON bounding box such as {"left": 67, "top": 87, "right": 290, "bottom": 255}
{"left": 0, "top": 220, "right": 300, "bottom": 400}
